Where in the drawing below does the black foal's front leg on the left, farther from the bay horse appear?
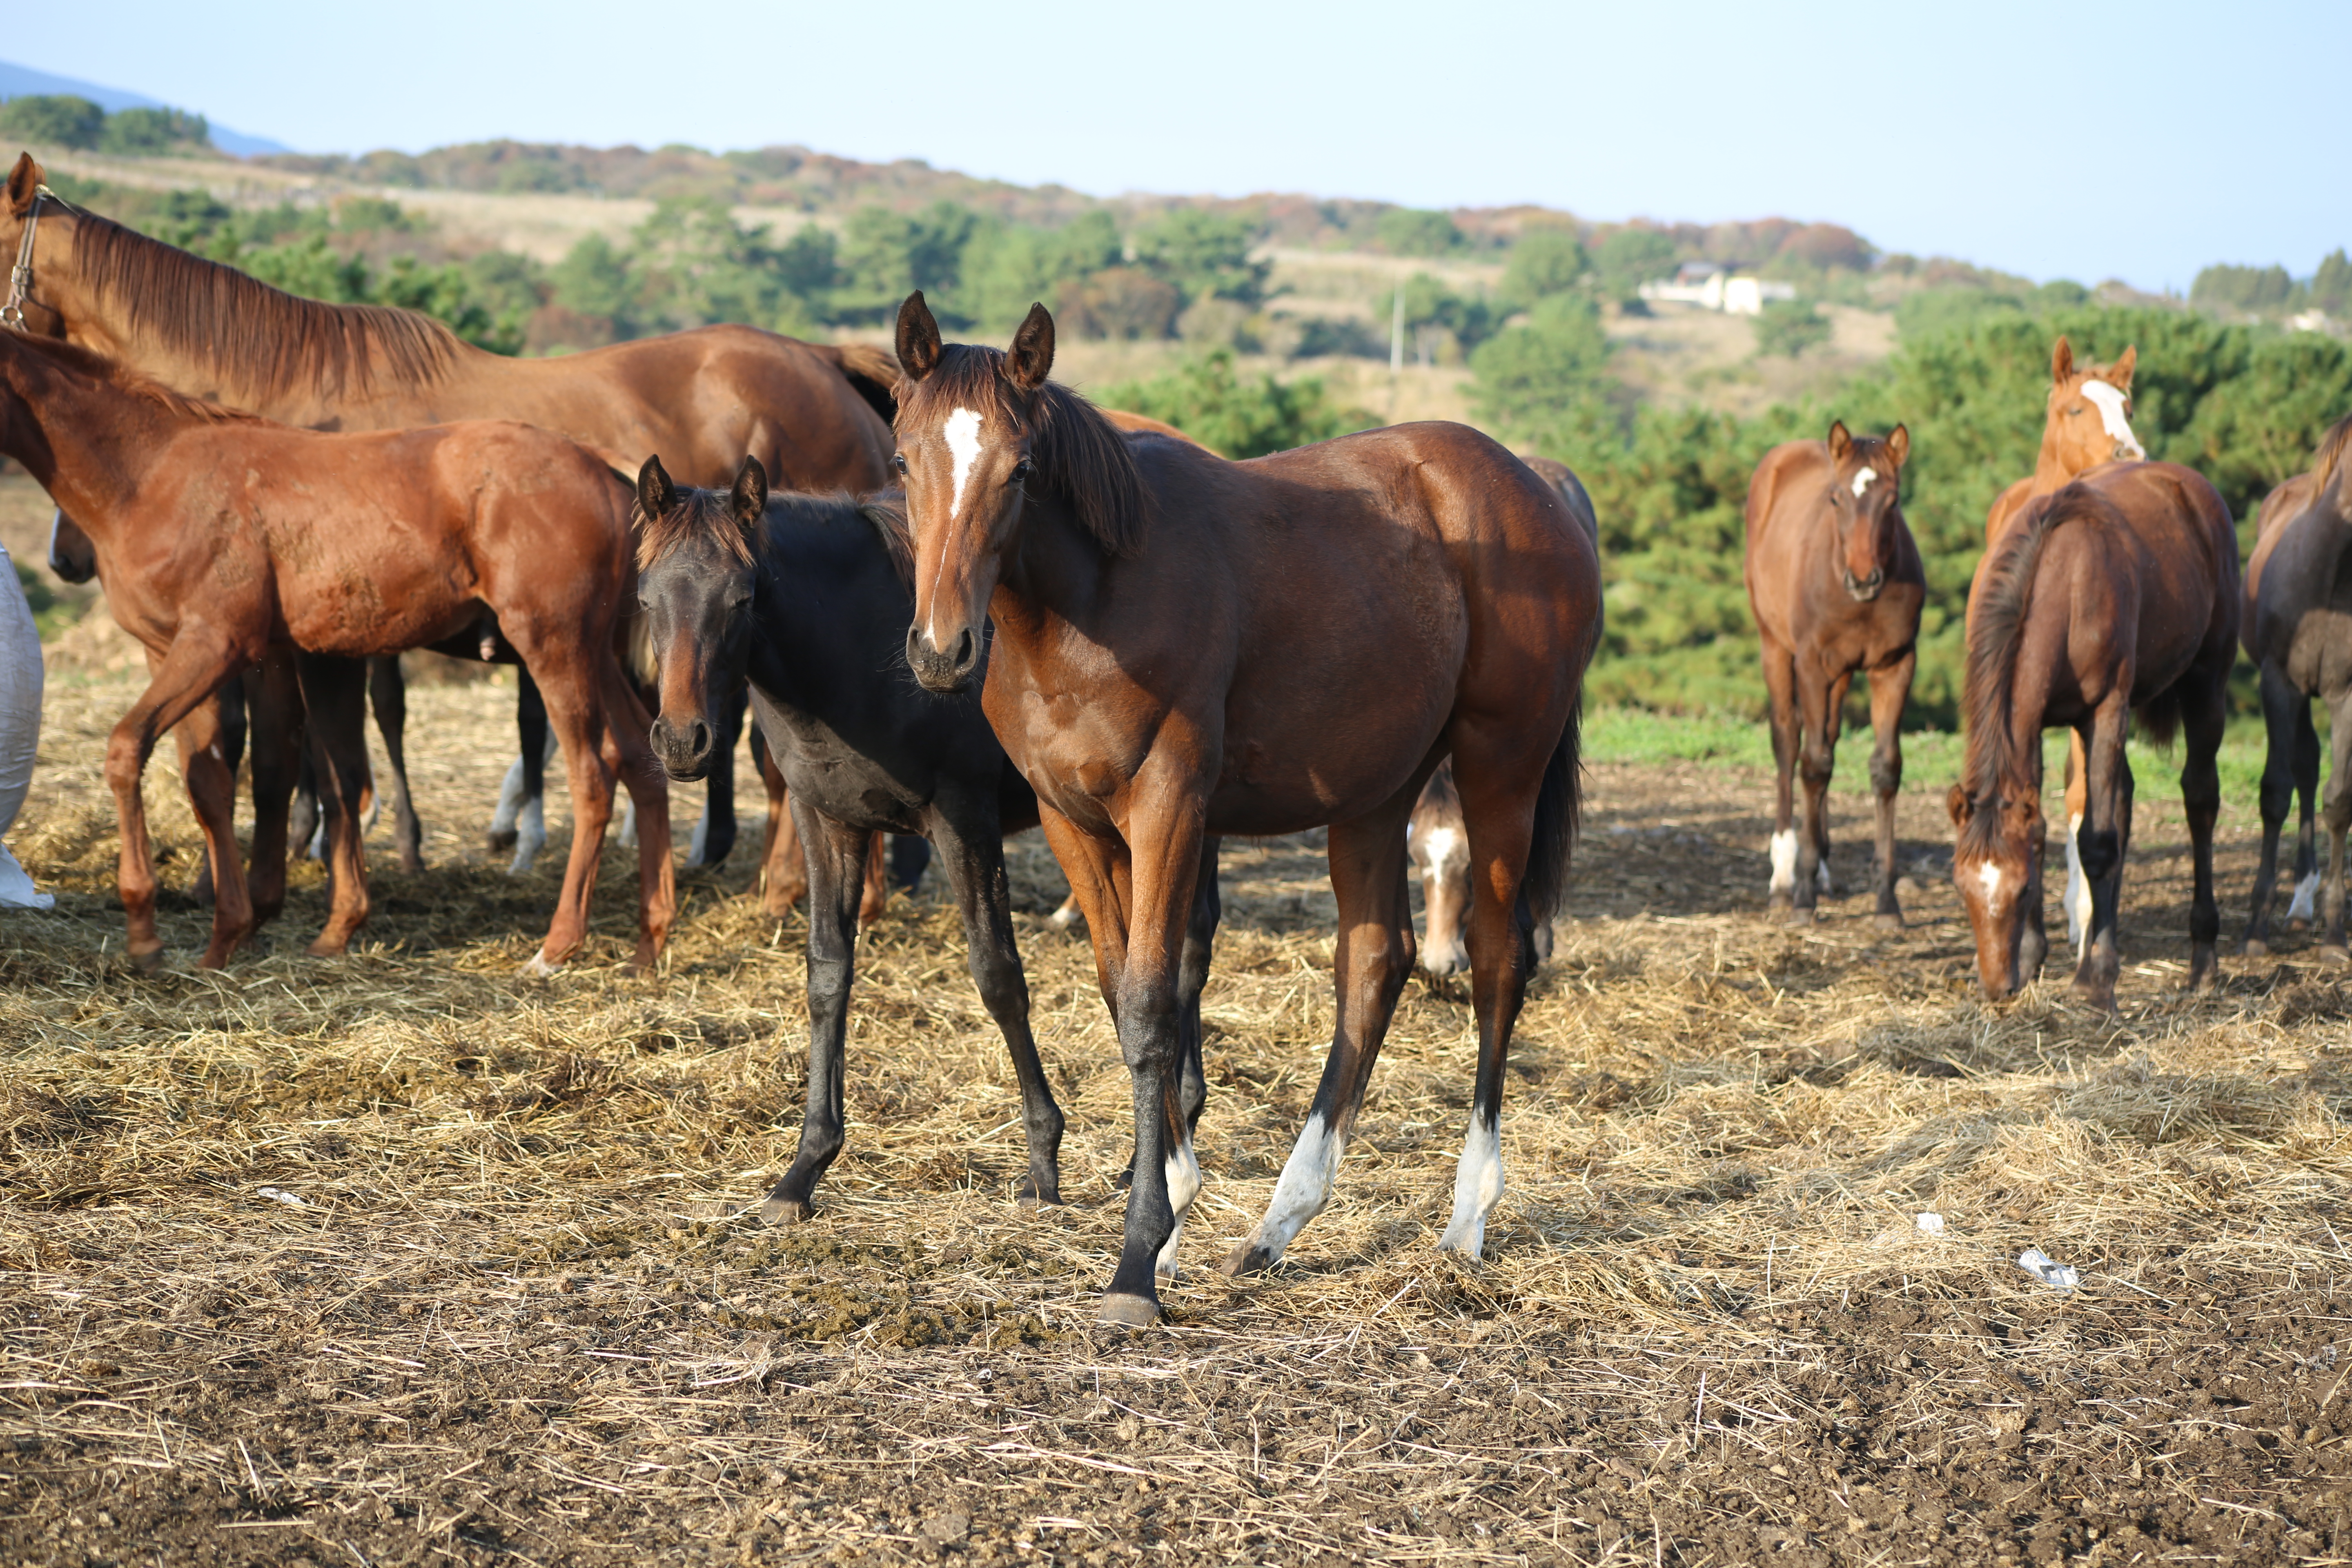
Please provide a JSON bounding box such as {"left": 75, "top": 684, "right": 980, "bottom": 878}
{"left": 760, "top": 799, "right": 880, "bottom": 1225}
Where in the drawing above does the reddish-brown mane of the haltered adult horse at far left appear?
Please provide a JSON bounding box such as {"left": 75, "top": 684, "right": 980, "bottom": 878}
{"left": 73, "top": 216, "right": 461, "bottom": 397}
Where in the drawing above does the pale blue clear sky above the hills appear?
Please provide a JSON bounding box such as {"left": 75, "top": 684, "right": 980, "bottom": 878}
{"left": 0, "top": 0, "right": 2352, "bottom": 289}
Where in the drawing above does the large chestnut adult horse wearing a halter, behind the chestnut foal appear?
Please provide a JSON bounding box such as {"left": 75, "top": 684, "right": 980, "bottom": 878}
{"left": 0, "top": 153, "right": 894, "bottom": 884}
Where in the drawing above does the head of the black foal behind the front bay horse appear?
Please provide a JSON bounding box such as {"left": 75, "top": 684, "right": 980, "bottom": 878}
{"left": 637, "top": 456, "right": 767, "bottom": 778}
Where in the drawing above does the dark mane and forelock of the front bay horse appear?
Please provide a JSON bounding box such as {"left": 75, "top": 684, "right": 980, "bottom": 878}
{"left": 898, "top": 343, "right": 1148, "bottom": 555}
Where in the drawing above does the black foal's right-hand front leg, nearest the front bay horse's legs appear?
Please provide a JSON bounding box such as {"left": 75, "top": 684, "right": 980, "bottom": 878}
{"left": 927, "top": 780, "right": 1063, "bottom": 1204}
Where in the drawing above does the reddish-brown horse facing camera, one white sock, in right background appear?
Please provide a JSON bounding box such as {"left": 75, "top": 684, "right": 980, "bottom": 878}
{"left": 1748, "top": 421, "right": 1926, "bottom": 926}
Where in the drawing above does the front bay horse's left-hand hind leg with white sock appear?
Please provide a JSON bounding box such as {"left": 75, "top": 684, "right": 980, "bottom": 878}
{"left": 1225, "top": 804, "right": 1411, "bottom": 1274}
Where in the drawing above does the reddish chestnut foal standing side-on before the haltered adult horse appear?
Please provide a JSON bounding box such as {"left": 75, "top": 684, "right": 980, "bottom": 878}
{"left": 0, "top": 332, "right": 675, "bottom": 973}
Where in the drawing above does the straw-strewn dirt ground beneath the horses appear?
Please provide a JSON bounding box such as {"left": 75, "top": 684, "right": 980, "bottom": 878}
{"left": 0, "top": 677, "right": 2352, "bottom": 1568}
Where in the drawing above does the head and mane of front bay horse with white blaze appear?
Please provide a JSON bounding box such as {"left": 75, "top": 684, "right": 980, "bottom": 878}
{"left": 891, "top": 292, "right": 1143, "bottom": 691}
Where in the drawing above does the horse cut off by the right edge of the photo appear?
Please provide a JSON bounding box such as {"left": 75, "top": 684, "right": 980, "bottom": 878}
{"left": 2244, "top": 416, "right": 2352, "bottom": 962}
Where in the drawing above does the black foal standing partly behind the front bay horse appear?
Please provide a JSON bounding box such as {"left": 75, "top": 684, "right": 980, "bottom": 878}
{"left": 637, "top": 456, "right": 1218, "bottom": 1223}
